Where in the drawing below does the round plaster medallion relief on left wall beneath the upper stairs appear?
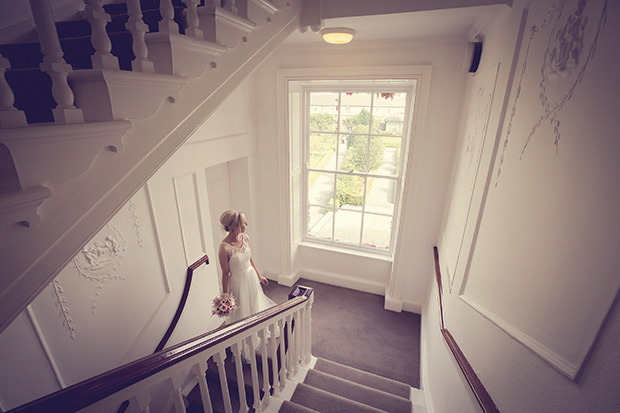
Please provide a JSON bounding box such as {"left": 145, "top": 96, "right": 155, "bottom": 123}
{"left": 72, "top": 224, "right": 126, "bottom": 315}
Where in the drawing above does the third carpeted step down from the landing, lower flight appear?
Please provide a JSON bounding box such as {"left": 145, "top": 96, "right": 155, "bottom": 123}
{"left": 291, "top": 383, "right": 385, "bottom": 413}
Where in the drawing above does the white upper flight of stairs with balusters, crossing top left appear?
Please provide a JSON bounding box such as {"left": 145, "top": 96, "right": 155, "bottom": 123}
{"left": 0, "top": 0, "right": 301, "bottom": 331}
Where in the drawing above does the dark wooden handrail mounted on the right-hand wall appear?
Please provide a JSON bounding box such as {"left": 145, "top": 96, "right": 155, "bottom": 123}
{"left": 433, "top": 247, "right": 499, "bottom": 413}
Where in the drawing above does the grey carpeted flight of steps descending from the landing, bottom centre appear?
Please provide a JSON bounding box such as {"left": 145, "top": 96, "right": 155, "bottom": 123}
{"left": 280, "top": 358, "right": 412, "bottom": 413}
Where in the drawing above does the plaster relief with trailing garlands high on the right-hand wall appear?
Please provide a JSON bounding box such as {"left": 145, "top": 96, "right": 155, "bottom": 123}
{"left": 495, "top": 0, "right": 607, "bottom": 186}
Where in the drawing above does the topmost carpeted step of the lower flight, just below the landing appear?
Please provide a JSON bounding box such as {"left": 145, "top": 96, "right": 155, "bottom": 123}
{"left": 314, "top": 358, "right": 411, "bottom": 399}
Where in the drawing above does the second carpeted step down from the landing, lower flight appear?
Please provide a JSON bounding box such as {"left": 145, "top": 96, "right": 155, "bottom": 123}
{"left": 304, "top": 369, "right": 411, "bottom": 413}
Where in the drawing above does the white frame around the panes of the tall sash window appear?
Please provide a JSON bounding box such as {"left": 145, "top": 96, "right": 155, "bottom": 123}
{"left": 278, "top": 66, "right": 431, "bottom": 262}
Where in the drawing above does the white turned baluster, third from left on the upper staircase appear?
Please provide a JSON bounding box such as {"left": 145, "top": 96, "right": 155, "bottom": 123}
{"left": 81, "top": 0, "right": 118, "bottom": 70}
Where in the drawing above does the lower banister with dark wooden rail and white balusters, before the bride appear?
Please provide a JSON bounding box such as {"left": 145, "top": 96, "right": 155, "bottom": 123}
{"left": 11, "top": 288, "right": 314, "bottom": 412}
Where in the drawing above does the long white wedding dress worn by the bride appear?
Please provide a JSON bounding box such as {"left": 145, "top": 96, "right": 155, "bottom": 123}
{"left": 222, "top": 234, "right": 276, "bottom": 324}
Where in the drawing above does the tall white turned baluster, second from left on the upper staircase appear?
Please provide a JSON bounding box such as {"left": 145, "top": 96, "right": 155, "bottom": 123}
{"left": 30, "top": 0, "right": 84, "bottom": 123}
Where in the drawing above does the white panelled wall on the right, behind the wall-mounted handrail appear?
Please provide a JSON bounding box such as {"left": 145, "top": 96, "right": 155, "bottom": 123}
{"left": 423, "top": 0, "right": 620, "bottom": 412}
